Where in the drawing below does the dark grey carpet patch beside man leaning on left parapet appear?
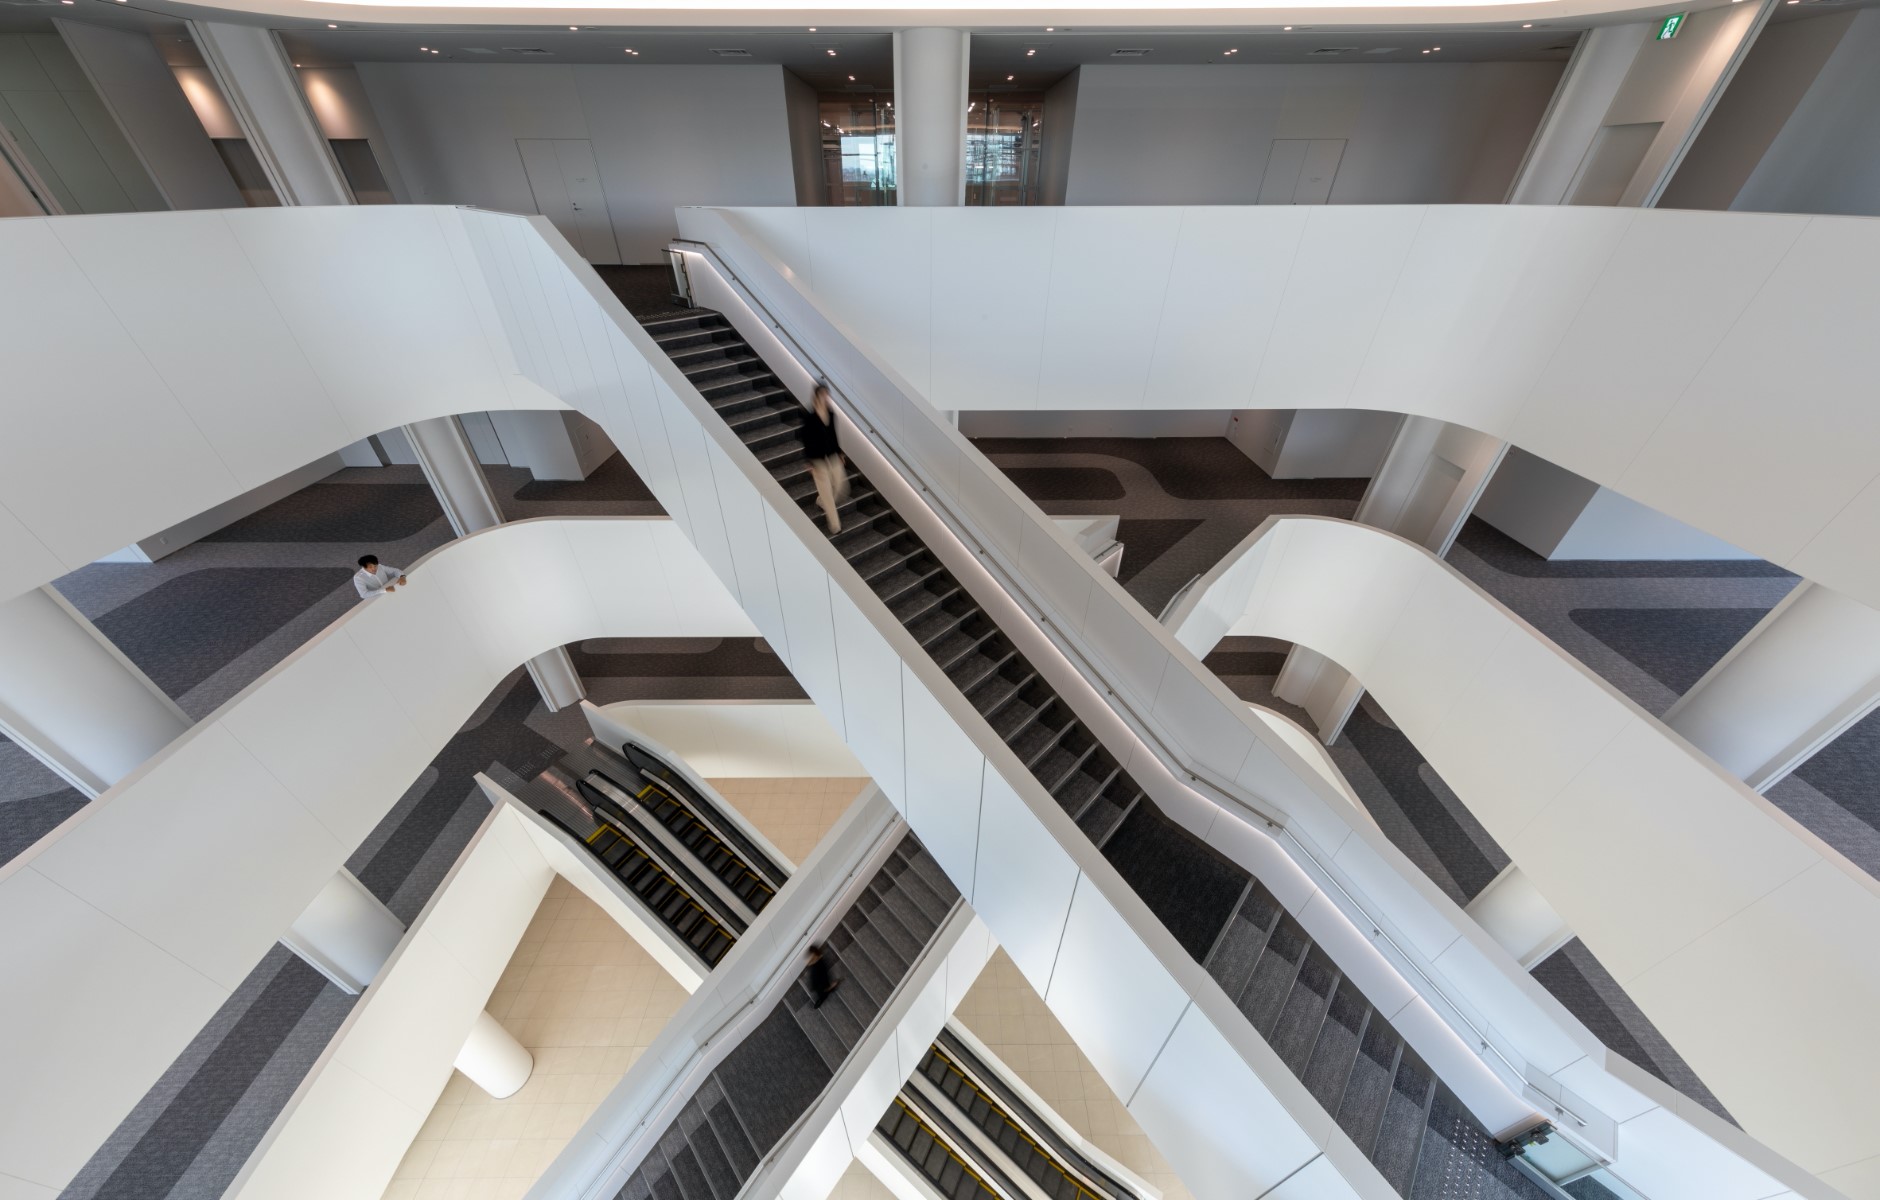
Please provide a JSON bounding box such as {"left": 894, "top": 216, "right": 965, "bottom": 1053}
{"left": 94, "top": 571, "right": 363, "bottom": 696}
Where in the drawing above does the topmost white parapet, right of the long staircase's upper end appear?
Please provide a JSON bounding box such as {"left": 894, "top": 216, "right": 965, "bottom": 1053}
{"left": 699, "top": 205, "right": 1880, "bottom": 606}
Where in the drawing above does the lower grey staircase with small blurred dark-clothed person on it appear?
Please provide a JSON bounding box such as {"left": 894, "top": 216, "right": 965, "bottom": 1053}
{"left": 617, "top": 833, "right": 959, "bottom": 1200}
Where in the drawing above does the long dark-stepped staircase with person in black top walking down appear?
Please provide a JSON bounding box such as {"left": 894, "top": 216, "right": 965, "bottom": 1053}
{"left": 643, "top": 308, "right": 1543, "bottom": 1200}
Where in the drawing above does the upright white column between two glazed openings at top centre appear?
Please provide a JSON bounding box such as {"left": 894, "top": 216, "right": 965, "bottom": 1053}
{"left": 895, "top": 28, "right": 972, "bottom": 209}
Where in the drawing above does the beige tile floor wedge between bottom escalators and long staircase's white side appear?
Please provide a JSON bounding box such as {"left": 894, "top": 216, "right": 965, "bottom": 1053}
{"left": 953, "top": 950, "right": 1190, "bottom": 1200}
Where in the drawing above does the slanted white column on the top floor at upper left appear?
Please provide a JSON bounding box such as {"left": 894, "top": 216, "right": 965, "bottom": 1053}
{"left": 190, "top": 21, "right": 353, "bottom": 205}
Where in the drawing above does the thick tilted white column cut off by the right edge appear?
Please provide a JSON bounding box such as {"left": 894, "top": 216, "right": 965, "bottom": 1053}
{"left": 1664, "top": 581, "right": 1880, "bottom": 792}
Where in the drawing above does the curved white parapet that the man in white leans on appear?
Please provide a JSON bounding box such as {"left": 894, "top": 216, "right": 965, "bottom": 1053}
{"left": 0, "top": 517, "right": 756, "bottom": 1189}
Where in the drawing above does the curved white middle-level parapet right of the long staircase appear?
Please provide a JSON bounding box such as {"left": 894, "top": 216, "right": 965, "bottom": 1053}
{"left": 1169, "top": 517, "right": 1880, "bottom": 1192}
